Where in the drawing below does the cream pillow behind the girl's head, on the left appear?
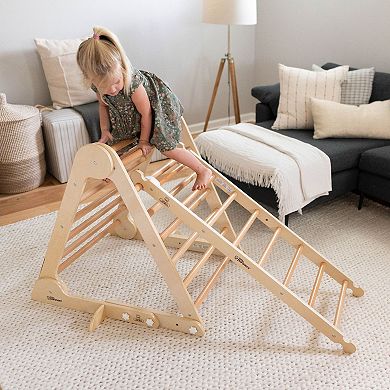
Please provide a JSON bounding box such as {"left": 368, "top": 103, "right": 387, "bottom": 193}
{"left": 35, "top": 39, "right": 97, "bottom": 109}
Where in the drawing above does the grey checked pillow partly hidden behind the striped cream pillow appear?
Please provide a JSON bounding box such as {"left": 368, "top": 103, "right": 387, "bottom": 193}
{"left": 312, "top": 64, "right": 375, "bottom": 105}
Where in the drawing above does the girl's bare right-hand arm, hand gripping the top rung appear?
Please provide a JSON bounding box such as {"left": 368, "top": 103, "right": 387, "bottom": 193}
{"left": 131, "top": 85, "right": 152, "bottom": 156}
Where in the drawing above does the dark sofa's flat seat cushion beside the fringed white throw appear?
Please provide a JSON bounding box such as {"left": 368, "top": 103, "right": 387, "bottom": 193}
{"left": 257, "top": 120, "right": 390, "bottom": 173}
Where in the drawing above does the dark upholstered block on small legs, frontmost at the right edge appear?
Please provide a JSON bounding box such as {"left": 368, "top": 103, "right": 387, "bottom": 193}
{"left": 358, "top": 146, "right": 390, "bottom": 209}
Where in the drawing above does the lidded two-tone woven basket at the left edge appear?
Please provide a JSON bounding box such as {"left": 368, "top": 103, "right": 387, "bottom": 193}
{"left": 0, "top": 93, "right": 46, "bottom": 194}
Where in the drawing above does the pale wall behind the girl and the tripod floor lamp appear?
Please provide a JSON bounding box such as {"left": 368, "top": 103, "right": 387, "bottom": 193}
{"left": 0, "top": 0, "right": 255, "bottom": 124}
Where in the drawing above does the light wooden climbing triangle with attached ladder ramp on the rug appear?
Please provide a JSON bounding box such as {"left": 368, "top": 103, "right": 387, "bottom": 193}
{"left": 32, "top": 120, "right": 364, "bottom": 353}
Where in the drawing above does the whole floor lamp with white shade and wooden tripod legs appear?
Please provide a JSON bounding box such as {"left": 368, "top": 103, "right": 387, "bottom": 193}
{"left": 203, "top": 0, "right": 257, "bottom": 131}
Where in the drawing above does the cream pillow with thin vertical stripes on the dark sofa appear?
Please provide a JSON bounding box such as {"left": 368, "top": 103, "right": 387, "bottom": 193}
{"left": 272, "top": 64, "right": 348, "bottom": 130}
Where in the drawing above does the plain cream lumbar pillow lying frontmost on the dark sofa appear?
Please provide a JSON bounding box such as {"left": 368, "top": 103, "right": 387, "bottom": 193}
{"left": 311, "top": 98, "right": 390, "bottom": 139}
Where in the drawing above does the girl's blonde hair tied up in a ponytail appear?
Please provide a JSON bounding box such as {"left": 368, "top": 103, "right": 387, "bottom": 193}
{"left": 77, "top": 27, "right": 133, "bottom": 95}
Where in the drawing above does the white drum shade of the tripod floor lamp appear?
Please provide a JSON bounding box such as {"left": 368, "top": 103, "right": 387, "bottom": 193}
{"left": 202, "top": 0, "right": 257, "bottom": 24}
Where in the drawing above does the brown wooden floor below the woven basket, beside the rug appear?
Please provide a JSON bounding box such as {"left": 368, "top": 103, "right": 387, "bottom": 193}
{"left": 0, "top": 160, "right": 168, "bottom": 226}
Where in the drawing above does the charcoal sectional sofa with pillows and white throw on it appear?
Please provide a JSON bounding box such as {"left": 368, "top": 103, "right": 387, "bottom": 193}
{"left": 229, "top": 63, "right": 390, "bottom": 222}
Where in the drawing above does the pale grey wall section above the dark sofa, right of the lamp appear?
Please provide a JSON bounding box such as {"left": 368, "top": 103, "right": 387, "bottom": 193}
{"left": 255, "top": 0, "right": 390, "bottom": 85}
